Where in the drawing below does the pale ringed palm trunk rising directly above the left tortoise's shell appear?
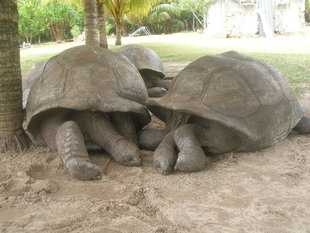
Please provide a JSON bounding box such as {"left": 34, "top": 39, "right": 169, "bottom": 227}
{"left": 83, "top": 0, "right": 98, "bottom": 46}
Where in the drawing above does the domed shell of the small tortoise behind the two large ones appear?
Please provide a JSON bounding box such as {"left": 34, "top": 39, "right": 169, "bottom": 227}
{"left": 117, "top": 45, "right": 165, "bottom": 78}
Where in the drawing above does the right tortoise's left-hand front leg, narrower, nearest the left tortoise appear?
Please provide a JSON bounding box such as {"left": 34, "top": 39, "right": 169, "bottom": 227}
{"left": 153, "top": 131, "right": 177, "bottom": 175}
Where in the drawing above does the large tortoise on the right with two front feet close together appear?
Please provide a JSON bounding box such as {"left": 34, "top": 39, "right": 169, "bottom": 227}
{"left": 141, "top": 51, "right": 310, "bottom": 174}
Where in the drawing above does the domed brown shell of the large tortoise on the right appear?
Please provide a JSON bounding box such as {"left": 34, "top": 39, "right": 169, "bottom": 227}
{"left": 149, "top": 51, "right": 304, "bottom": 151}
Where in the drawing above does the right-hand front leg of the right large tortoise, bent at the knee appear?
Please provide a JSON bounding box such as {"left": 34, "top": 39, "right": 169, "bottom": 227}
{"left": 174, "top": 124, "right": 207, "bottom": 172}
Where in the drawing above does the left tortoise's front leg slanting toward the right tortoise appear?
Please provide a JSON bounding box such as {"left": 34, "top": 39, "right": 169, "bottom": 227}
{"left": 76, "top": 112, "right": 141, "bottom": 166}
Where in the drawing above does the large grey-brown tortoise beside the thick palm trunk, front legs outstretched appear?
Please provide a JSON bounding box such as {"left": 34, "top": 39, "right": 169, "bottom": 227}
{"left": 26, "top": 45, "right": 150, "bottom": 180}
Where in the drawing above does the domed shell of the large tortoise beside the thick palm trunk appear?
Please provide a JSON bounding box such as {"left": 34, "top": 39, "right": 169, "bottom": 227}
{"left": 26, "top": 45, "right": 150, "bottom": 141}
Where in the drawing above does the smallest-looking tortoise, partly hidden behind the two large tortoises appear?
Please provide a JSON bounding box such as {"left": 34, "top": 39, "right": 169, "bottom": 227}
{"left": 117, "top": 45, "right": 170, "bottom": 97}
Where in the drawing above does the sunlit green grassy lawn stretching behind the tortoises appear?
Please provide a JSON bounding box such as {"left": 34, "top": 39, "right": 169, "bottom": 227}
{"left": 21, "top": 33, "right": 310, "bottom": 92}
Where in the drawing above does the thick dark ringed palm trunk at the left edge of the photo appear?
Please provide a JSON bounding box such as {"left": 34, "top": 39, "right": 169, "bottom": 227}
{"left": 0, "top": 0, "right": 28, "bottom": 152}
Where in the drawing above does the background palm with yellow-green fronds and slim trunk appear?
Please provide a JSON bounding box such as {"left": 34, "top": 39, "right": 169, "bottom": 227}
{"left": 104, "top": 0, "right": 155, "bottom": 45}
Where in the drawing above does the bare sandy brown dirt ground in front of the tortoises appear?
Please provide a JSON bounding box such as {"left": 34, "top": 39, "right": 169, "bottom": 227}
{"left": 0, "top": 63, "right": 310, "bottom": 233}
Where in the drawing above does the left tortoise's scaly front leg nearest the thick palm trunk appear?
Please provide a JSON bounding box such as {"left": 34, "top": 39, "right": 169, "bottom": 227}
{"left": 56, "top": 121, "right": 102, "bottom": 180}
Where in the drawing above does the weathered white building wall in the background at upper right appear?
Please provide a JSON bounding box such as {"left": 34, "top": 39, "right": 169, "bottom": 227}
{"left": 205, "top": 0, "right": 305, "bottom": 37}
